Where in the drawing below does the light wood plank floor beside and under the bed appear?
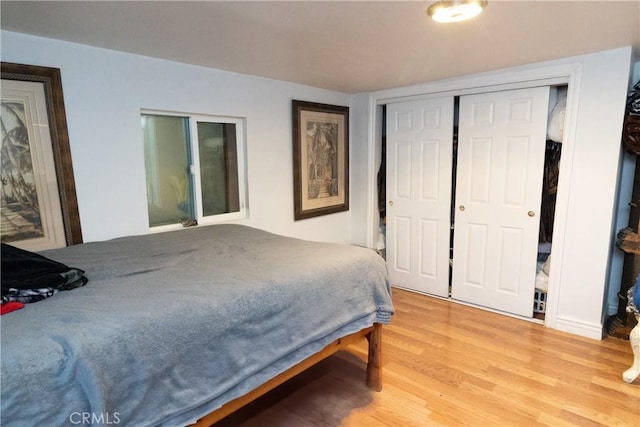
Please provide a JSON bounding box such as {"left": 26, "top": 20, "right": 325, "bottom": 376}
{"left": 216, "top": 289, "right": 640, "bottom": 427}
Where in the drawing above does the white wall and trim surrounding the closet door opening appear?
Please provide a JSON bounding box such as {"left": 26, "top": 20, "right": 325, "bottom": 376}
{"left": 363, "top": 48, "right": 632, "bottom": 339}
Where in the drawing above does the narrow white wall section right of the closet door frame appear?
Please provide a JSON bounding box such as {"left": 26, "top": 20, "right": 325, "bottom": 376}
{"left": 554, "top": 48, "right": 632, "bottom": 338}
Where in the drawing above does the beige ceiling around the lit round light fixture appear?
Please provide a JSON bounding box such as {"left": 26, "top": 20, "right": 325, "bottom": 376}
{"left": 0, "top": 0, "right": 640, "bottom": 93}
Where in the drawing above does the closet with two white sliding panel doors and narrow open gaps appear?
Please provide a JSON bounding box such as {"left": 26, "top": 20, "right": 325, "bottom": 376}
{"left": 386, "top": 86, "right": 566, "bottom": 317}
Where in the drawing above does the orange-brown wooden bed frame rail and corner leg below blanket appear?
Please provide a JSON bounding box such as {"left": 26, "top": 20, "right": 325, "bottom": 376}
{"left": 192, "top": 323, "right": 382, "bottom": 427}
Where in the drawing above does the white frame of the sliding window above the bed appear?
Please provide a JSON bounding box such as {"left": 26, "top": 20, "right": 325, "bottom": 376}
{"left": 140, "top": 109, "right": 249, "bottom": 233}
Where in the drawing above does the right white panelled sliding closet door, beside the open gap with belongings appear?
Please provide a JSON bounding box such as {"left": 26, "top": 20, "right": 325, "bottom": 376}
{"left": 451, "top": 87, "right": 549, "bottom": 317}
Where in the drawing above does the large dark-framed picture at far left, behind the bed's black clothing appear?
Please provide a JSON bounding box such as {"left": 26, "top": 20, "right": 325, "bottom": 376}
{"left": 0, "top": 62, "right": 82, "bottom": 251}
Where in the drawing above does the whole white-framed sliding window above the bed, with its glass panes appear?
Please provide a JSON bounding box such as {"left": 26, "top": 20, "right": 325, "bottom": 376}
{"left": 142, "top": 112, "right": 247, "bottom": 229}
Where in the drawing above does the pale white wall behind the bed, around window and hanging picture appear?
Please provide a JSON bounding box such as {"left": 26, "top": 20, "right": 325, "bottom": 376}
{"left": 1, "top": 31, "right": 356, "bottom": 246}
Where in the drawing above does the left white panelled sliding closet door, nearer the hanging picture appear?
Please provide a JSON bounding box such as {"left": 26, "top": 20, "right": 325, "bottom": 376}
{"left": 387, "top": 97, "right": 453, "bottom": 297}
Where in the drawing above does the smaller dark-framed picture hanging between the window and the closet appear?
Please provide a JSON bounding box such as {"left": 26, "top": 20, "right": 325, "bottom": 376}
{"left": 292, "top": 100, "right": 349, "bottom": 221}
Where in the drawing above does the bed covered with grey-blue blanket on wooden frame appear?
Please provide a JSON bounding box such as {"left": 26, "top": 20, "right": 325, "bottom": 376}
{"left": 0, "top": 224, "right": 394, "bottom": 426}
